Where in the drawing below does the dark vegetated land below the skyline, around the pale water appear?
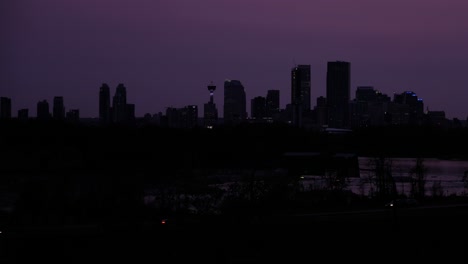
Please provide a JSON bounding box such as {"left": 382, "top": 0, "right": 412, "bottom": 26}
{"left": 0, "top": 121, "right": 468, "bottom": 263}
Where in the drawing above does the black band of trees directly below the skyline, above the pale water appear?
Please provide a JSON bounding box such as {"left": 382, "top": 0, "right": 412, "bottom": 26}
{"left": 0, "top": 119, "right": 468, "bottom": 173}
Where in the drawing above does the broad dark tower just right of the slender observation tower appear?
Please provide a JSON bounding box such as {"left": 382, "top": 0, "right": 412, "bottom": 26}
{"left": 224, "top": 80, "right": 247, "bottom": 125}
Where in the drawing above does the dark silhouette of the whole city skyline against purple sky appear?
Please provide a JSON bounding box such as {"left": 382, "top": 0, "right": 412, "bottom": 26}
{"left": 0, "top": 61, "right": 466, "bottom": 128}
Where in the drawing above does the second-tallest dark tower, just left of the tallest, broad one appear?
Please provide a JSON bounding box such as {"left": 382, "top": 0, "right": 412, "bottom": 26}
{"left": 291, "top": 65, "right": 310, "bottom": 126}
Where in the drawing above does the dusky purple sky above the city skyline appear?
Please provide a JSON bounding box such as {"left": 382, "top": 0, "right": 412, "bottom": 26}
{"left": 0, "top": 0, "right": 468, "bottom": 119}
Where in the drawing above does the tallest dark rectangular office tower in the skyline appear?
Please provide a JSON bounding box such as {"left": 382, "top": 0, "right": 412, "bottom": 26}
{"left": 327, "top": 61, "right": 351, "bottom": 128}
